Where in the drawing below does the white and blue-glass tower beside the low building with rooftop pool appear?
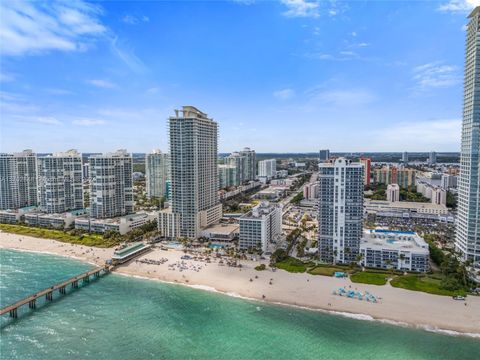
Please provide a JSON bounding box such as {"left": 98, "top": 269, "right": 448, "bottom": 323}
{"left": 318, "top": 158, "right": 363, "bottom": 263}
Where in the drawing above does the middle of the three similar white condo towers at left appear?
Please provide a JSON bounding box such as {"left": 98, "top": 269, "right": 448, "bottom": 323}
{"left": 37, "top": 150, "right": 83, "bottom": 214}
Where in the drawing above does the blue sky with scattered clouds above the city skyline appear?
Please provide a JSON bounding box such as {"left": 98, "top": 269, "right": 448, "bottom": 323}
{"left": 0, "top": 0, "right": 478, "bottom": 152}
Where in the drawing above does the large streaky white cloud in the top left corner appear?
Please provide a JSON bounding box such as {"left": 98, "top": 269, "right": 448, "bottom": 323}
{"left": 0, "top": 0, "right": 106, "bottom": 56}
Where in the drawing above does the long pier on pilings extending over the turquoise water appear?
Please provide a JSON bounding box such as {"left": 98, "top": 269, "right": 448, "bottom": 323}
{"left": 0, "top": 266, "right": 113, "bottom": 318}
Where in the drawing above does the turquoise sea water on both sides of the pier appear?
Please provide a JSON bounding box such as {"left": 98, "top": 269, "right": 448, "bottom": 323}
{"left": 0, "top": 250, "right": 480, "bottom": 360}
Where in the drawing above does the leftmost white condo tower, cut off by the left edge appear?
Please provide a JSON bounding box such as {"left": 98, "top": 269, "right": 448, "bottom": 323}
{"left": 0, "top": 150, "right": 38, "bottom": 210}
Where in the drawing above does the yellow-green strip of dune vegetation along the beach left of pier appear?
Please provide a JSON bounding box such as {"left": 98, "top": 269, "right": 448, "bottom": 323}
{"left": 0, "top": 224, "right": 118, "bottom": 248}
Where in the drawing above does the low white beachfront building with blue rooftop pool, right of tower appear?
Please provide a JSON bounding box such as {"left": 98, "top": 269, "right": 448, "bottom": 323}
{"left": 360, "top": 229, "right": 429, "bottom": 272}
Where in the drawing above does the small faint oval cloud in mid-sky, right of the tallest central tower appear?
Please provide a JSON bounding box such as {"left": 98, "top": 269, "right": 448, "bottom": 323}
{"left": 307, "top": 88, "right": 377, "bottom": 107}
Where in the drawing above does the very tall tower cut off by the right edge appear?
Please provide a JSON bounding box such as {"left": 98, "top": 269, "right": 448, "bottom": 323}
{"left": 455, "top": 7, "right": 480, "bottom": 265}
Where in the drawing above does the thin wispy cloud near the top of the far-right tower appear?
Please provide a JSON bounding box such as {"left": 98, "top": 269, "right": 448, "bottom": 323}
{"left": 413, "top": 61, "right": 461, "bottom": 90}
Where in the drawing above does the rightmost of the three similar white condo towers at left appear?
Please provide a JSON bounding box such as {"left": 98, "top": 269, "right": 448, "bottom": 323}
{"left": 88, "top": 150, "right": 134, "bottom": 219}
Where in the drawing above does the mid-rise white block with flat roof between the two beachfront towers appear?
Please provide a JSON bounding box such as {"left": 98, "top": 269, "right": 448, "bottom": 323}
{"left": 238, "top": 202, "right": 282, "bottom": 252}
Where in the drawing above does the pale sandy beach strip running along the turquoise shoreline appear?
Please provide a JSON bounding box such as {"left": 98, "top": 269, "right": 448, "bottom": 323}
{"left": 0, "top": 232, "right": 480, "bottom": 338}
